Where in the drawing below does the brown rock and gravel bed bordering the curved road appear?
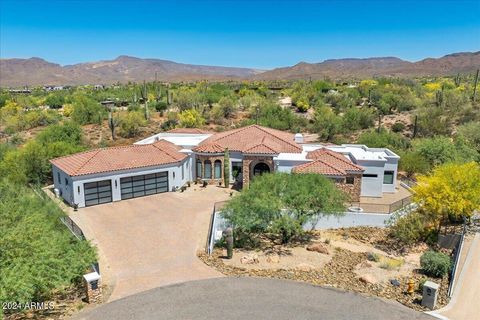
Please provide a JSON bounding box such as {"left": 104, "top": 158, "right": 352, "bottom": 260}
{"left": 198, "top": 228, "right": 448, "bottom": 311}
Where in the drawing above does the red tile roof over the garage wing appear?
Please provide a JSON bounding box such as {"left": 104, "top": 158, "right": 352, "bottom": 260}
{"left": 50, "top": 140, "right": 187, "bottom": 176}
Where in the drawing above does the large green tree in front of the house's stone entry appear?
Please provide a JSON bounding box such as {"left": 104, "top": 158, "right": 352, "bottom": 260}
{"left": 222, "top": 173, "right": 346, "bottom": 244}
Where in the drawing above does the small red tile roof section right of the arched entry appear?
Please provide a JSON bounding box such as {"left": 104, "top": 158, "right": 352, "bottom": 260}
{"left": 292, "top": 148, "right": 363, "bottom": 176}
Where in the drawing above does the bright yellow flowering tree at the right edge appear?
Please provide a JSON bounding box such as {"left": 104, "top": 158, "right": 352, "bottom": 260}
{"left": 414, "top": 162, "right": 480, "bottom": 226}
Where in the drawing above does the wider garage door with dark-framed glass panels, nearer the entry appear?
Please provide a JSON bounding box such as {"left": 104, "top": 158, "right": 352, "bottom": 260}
{"left": 120, "top": 172, "right": 168, "bottom": 200}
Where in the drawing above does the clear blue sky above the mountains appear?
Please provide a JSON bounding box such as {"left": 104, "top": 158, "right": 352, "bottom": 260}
{"left": 0, "top": 0, "right": 480, "bottom": 69}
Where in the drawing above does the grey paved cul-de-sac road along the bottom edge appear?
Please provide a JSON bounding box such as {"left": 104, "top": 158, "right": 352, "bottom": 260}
{"left": 74, "top": 278, "right": 434, "bottom": 320}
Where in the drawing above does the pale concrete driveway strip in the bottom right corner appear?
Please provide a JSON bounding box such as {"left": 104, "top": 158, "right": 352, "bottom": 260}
{"left": 433, "top": 233, "right": 480, "bottom": 320}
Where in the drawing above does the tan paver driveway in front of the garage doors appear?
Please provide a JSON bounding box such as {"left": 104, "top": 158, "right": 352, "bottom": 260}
{"left": 71, "top": 186, "right": 229, "bottom": 301}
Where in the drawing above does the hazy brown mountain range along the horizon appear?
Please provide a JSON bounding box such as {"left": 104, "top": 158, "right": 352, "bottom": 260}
{"left": 0, "top": 51, "right": 480, "bottom": 87}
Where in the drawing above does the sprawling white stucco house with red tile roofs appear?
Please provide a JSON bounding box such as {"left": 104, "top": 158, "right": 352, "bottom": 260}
{"left": 51, "top": 125, "right": 399, "bottom": 207}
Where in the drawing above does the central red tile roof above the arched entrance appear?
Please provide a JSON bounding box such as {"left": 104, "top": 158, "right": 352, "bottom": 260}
{"left": 200, "top": 125, "right": 302, "bottom": 154}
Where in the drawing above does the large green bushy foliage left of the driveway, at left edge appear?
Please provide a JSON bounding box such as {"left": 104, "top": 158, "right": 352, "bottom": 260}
{"left": 0, "top": 180, "right": 96, "bottom": 302}
